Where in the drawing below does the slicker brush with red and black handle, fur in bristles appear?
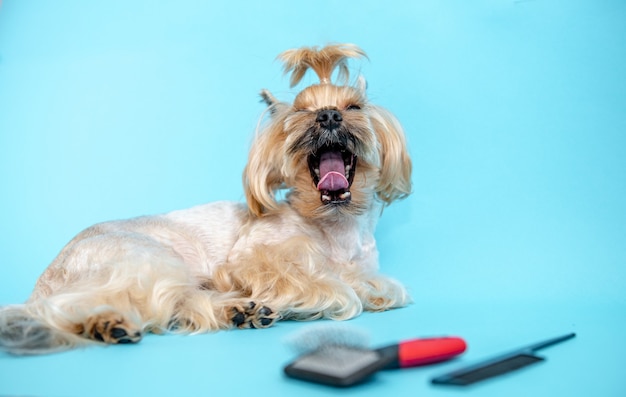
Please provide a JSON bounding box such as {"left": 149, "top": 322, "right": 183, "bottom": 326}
{"left": 284, "top": 328, "right": 467, "bottom": 387}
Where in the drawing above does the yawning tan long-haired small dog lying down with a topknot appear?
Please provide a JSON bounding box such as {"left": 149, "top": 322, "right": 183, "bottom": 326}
{"left": 0, "top": 44, "right": 411, "bottom": 354}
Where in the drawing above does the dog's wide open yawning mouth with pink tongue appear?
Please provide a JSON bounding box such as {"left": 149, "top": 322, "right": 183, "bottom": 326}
{"left": 308, "top": 147, "right": 356, "bottom": 204}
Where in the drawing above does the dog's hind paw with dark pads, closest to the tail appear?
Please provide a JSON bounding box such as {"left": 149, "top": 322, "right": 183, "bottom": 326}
{"left": 83, "top": 311, "right": 142, "bottom": 344}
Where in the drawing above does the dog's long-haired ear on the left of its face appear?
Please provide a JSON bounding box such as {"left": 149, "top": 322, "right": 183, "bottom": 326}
{"left": 243, "top": 90, "right": 289, "bottom": 216}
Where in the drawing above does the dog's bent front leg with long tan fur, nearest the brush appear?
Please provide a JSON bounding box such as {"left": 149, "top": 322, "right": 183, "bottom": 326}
{"left": 210, "top": 242, "right": 363, "bottom": 320}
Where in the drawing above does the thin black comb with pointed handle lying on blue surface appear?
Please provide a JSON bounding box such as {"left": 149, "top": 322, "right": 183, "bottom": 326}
{"left": 432, "top": 333, "right": 576, "bottom": 386}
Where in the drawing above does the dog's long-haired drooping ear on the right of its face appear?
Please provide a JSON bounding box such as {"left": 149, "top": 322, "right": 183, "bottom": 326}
{"left": 369, "top": 105, "right": 412, "bottom": 204}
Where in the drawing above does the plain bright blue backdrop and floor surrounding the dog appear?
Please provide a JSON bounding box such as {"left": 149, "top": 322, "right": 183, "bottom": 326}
{"left": 0, "top": 0, "right": 626, "bottom": 397}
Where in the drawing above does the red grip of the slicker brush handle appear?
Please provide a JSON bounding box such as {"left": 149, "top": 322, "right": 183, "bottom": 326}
{"left": 398, "top": 337, "right": 467, "bottom": 368}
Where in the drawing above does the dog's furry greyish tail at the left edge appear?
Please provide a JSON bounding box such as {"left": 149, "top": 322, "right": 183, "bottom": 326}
{"left": 0, "top": 301, "right": 89, "bottom": 355}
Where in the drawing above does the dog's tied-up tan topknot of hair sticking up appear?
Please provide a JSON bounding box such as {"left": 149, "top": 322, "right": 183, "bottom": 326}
{"left": 278, "top": 44, "right": 367, "bottom": 87}
